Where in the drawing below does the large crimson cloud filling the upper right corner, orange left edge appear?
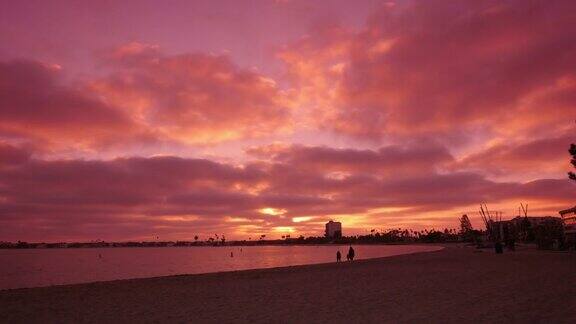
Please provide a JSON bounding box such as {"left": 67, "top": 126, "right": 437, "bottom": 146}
{"left": 282, "top": 1, "right": 576, "bottom": 143}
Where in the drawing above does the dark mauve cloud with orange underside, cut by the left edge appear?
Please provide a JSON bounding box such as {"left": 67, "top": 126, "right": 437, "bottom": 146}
{"left": 0, "top": 61, "right": 138, "bottom": 149}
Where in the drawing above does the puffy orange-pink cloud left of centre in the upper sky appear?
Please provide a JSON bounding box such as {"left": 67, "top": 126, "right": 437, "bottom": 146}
{"left": 92, "top": 43, "right": 290, "bottom": 144}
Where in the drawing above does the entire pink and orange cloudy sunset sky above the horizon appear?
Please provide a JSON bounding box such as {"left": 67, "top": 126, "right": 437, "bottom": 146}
{"left": 0, "top": 0, "right": 576, "bottom": 242}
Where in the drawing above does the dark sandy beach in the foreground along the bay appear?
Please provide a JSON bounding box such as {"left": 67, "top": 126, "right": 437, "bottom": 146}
{"left": 0, "top": 245, "right": 576, "bottom": 323}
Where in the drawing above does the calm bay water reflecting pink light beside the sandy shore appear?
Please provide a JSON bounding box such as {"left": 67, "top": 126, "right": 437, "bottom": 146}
{"left": 0, "top": 245, "right": 441, "bottom": 289}
